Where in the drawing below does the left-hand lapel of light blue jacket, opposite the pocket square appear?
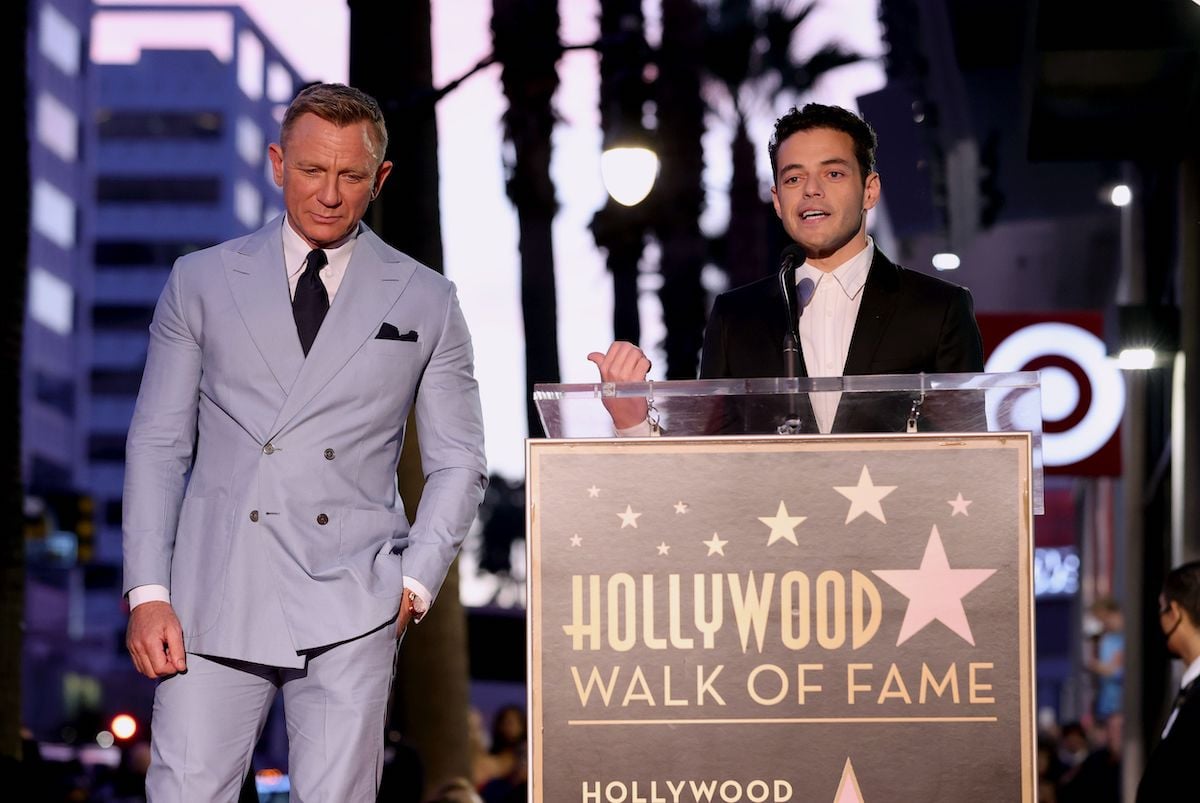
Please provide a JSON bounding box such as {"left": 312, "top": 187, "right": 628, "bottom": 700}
{"left": 224, "top": 218, "right": 304, "bottom": 394}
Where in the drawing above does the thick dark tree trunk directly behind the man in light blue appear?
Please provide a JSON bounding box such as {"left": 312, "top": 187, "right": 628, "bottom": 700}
{"left": 349, "top": 0, "right": 470, "bottom": 799}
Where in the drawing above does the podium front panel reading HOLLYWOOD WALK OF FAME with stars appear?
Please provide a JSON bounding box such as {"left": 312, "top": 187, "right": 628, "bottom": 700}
{"left": 527, "top": 433, "right": 1037, "bottom": 803}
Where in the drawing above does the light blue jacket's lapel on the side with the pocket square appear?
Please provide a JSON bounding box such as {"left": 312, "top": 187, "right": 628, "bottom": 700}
{"left": 271, "top": 226, "right": 416, "bottom": 437}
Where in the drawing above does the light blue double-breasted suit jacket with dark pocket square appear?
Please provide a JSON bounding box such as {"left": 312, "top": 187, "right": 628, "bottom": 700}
{"left": 124, "top": 218, "right": 486, "bottom": 666}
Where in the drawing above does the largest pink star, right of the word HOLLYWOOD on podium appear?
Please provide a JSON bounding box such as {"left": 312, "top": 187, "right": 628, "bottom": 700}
{"left": 875, "top": 525, "right": 996, "bottom": 647}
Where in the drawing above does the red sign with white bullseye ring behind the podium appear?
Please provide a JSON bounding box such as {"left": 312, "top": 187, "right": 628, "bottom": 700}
{"left": 977, "top": 312, "right": 1126, "bottom": 475}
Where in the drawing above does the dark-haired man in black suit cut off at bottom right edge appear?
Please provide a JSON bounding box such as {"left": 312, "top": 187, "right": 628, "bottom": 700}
{"left": 1138, "top": 561, "right": 1200, "bottom": 803}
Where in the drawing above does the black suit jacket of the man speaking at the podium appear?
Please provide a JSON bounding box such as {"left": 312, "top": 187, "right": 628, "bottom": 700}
{"left": 700, "top": 247, "right": 983, "bottom": 432}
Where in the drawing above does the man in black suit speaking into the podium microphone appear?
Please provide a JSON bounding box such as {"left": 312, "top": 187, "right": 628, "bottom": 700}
{"left": 588, "top": 103, "right": 983, "bottom": 433}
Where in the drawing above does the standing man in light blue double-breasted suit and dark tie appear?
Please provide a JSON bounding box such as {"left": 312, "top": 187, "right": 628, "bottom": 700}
{"left": 117, "top": 84, "right": 487, "bottom": 803}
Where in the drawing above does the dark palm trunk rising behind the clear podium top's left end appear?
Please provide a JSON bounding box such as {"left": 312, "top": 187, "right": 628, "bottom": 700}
{"left": 492, "top": 0, "right": 563, "bottom": 437}
